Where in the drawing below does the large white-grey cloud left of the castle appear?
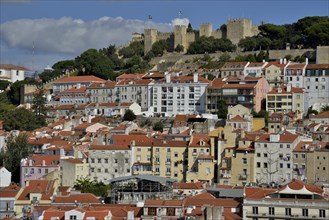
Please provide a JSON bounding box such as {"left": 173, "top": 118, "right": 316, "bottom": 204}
{"left": 0, "top": 17, "right": 171, "bottom": 54}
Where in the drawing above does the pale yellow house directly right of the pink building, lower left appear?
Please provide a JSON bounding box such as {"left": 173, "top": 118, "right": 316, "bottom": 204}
{"left": 61, "top": 158, "right": 89, "bottom": 186}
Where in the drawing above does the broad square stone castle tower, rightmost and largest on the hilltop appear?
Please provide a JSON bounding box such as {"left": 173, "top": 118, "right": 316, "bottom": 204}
{"left": 227, "top": 18, "right": 258, "bottom": 44}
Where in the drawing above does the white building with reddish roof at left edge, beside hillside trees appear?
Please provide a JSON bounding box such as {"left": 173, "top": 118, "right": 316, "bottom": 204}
{"left": 0, "top": 64, "right": 28, "bottom": 83}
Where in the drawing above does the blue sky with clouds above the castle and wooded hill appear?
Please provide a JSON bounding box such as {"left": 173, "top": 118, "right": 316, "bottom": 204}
{"left": 0, "top": 0, "right": 329, "bottom": 69}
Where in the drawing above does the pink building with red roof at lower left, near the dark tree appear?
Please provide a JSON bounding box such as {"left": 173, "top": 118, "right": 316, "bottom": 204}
{"left": 20, "top": 154, "right": 60, "bottom": 187}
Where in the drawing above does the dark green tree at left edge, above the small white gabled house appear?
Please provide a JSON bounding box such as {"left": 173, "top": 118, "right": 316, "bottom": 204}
{"left": 0, "top": 135, "right": 32, "bottom": 183}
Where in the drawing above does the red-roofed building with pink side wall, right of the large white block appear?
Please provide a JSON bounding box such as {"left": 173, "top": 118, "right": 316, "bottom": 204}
{"left": 206, "top": 77, "right": 270, "bottom": 114}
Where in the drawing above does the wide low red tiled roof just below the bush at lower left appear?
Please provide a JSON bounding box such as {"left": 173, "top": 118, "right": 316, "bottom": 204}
{"left": 53, "top": 193, "right": 101, "bottom": 204}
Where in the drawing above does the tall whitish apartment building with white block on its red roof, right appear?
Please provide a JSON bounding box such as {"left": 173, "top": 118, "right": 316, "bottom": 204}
{"left": 255, "top": 131, "right": 299, "bottom": 184}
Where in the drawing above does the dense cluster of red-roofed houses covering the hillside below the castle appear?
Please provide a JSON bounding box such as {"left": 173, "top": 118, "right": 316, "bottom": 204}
{"left": 0, "top": 60, "right": 329, "bottom": 220}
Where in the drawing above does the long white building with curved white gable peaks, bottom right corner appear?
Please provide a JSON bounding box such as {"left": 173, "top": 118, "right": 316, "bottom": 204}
{"left": 243, "top": 179, "right": 329, "bottom": 220}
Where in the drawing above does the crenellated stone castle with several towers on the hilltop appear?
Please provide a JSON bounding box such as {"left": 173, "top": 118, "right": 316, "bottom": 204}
{"left": 132, "top": 18, "right": 259, "bottom": 54}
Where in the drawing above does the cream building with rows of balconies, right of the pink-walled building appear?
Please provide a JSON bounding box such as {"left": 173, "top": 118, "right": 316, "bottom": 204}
{"left": 266, "top": 84, "right": 307, "bottom": 113}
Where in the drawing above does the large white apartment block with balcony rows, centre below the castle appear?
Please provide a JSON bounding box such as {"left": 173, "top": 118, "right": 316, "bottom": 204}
{"left": 150, "top": 73, "right": 210, "bottom": 117}
